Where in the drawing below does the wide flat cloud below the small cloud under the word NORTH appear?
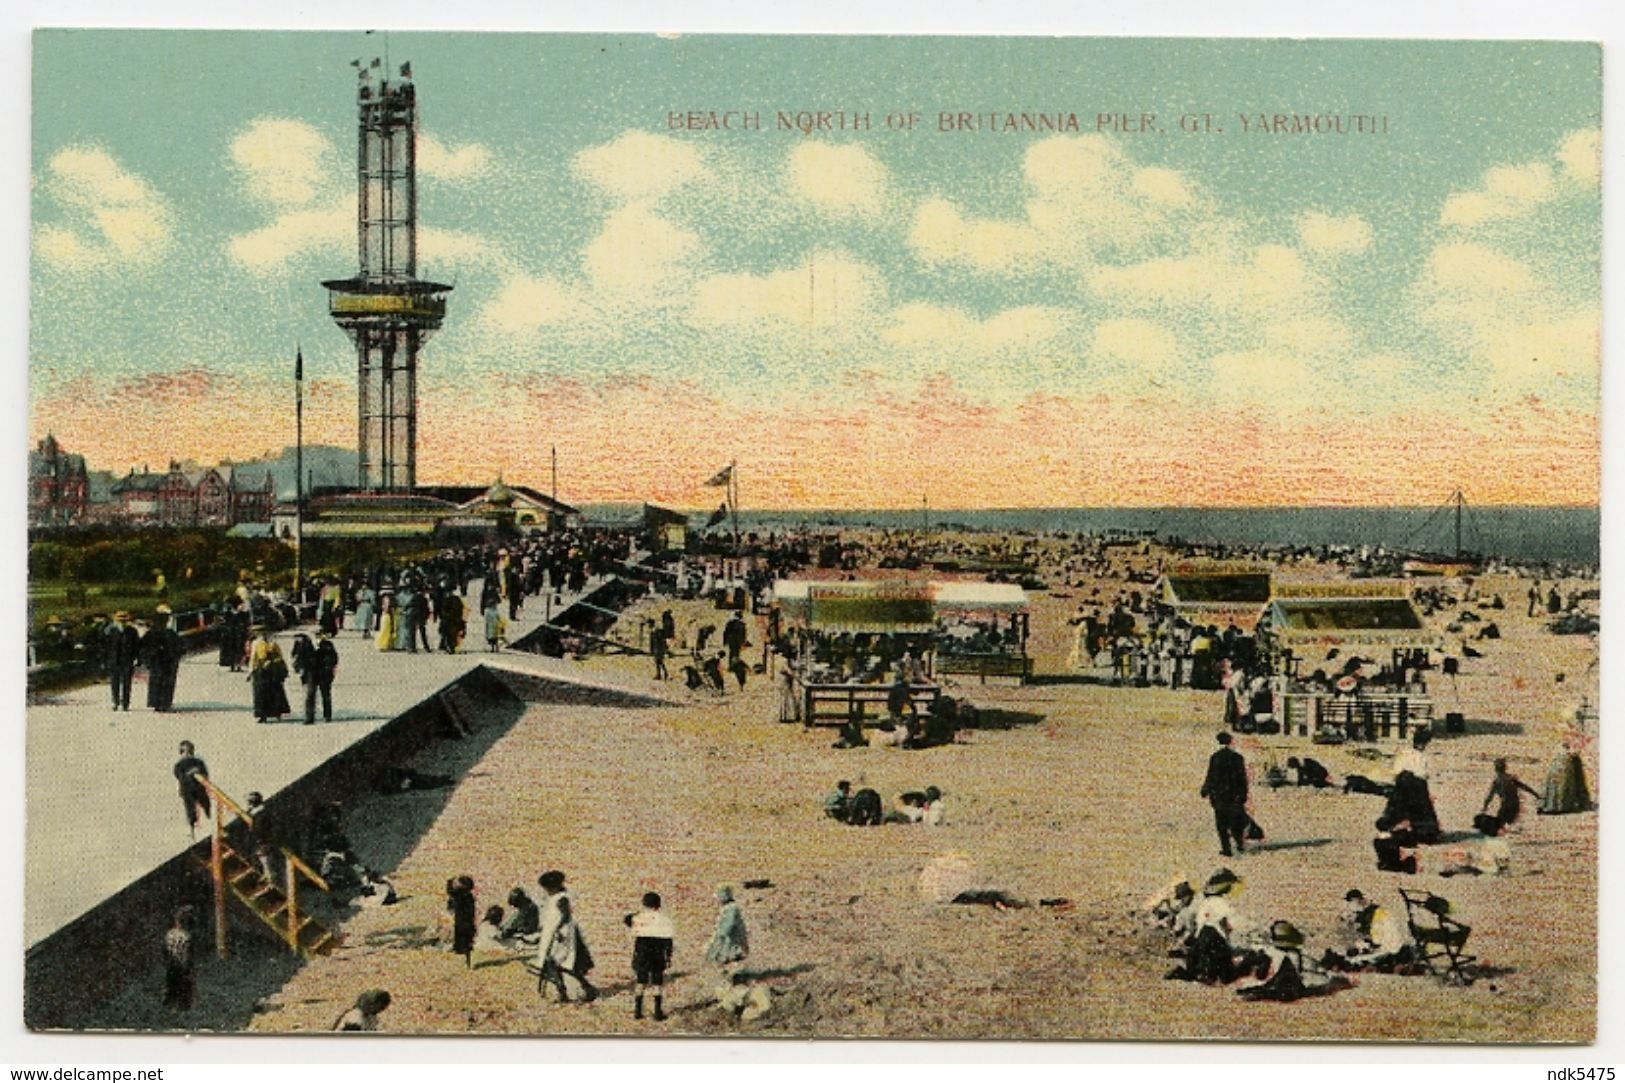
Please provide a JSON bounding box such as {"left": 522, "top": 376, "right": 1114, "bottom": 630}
{"left": 691, "top": 252, "right": 886, "bottom": 333}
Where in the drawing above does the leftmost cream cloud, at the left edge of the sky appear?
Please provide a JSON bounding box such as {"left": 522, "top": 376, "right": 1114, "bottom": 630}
{"left": 34, "top": 146, "right": 174, "bottom": 270}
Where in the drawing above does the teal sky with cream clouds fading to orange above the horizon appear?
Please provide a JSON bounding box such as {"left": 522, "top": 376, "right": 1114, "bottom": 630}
{"left": 29, "top": 31, "right": 1601, "bottom": 509}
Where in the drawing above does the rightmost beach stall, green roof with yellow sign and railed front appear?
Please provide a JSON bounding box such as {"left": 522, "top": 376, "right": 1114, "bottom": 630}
{"left": 1258, "top": 582, "right": 1441, "bottom": 742}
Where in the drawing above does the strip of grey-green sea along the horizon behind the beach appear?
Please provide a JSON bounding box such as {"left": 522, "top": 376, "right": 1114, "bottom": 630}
{"left": 582, "top": 504, "right": 1602, "bottom": 566}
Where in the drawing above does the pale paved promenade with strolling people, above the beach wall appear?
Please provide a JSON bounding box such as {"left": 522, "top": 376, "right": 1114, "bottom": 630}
{"left": 23, "top": 577, "right": 620, "bottom": 946}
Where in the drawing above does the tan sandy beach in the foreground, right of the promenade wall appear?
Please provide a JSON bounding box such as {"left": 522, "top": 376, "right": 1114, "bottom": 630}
{"left": 177, "top": 549, "right": 1597, "bottom": 1042}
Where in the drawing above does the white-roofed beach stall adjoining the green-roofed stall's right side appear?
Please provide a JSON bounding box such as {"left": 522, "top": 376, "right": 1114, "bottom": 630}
{"left": 931, "top": 582, "right": 1032, "bottom": 685}
